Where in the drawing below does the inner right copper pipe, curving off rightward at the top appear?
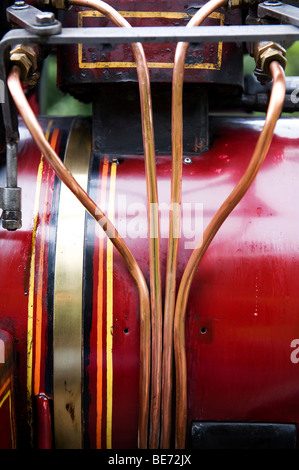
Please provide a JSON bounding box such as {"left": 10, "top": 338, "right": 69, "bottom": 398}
{"left": 160, "top": 0, "right": 226, "bottom": 449}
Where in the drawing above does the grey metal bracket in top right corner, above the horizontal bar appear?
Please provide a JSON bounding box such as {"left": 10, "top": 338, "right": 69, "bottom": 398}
{"left": 258, "top": 1, "right": 299, "bottom": 26}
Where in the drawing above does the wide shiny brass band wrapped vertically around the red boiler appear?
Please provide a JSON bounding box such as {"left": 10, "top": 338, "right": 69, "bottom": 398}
{"left": 53, "top": 119, "right": 91, "bottom": 449}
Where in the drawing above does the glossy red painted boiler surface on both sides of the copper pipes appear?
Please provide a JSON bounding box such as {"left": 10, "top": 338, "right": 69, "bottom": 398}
{"left": 0, "top": 114, "right": 299, "bottom": 448}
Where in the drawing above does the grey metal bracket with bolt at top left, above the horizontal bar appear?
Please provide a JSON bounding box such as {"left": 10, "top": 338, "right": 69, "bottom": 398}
{"left": 6, "top": 0, "right": 62, "bottom": 36}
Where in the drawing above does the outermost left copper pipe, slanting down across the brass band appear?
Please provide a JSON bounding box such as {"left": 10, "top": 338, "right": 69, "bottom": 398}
{"left": 7, "top": 66, "right": 151, "bottom": 448}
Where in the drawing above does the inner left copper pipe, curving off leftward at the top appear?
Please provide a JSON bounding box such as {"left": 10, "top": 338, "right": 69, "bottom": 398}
{"left": 69, "top": 0, "right": 162, "bottom": 449}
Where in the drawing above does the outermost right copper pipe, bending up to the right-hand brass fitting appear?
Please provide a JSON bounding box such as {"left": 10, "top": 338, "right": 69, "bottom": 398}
{"left": 174, "top": 61, "right": 285, "bottom": 448}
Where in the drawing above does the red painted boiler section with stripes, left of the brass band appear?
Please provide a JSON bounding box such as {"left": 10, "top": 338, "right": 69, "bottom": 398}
{"left": 0, "top": 115, "right": 73, "bottom": 447}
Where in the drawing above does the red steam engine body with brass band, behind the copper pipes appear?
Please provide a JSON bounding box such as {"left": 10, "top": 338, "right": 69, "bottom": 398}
{"left": 0, "top": 0, "right": 299, "bottom": 449}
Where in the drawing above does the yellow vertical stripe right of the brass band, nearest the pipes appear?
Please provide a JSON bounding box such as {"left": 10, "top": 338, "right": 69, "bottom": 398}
{"left": 106, "top": 163, "right": 117, "bottom": 449}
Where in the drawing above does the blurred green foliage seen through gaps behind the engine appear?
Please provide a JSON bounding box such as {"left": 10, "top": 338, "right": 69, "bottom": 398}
{"left": 40, "top": 41, "right": 299, "bottom": 116}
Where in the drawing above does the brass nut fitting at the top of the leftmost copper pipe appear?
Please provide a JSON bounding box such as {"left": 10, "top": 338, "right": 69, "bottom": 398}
{"left": 10, "top": 44, "right": 39, "bottom": 86}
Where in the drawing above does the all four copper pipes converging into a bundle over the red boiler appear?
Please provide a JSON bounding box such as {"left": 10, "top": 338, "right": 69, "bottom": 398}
{"left": 8, "top": 0, "right": 285, "bottom": 448}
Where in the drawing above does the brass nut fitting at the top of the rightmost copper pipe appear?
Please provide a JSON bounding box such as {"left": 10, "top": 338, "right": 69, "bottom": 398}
{"left": 253, "top": 41, "right": 287, "bottom": 83}
